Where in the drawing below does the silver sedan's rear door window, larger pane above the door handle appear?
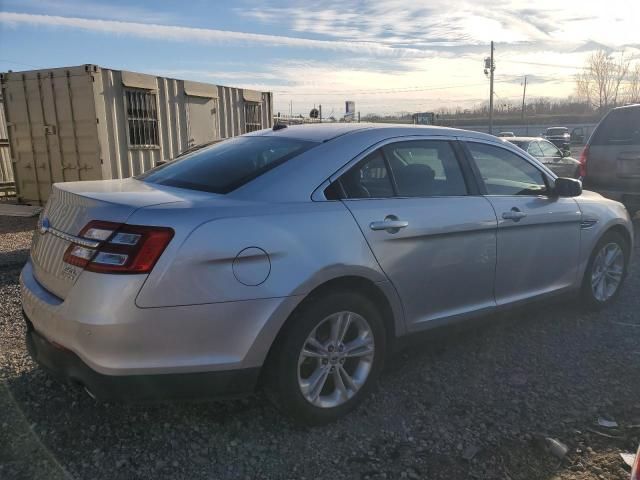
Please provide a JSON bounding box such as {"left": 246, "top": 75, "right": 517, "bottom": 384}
{"left": 384, "top": 140, "right": 467, "bottom": 197}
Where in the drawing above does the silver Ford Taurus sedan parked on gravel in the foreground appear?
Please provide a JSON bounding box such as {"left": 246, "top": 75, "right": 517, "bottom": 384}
{"left": 21, "top": 124, "right": 633, "bottom": 423}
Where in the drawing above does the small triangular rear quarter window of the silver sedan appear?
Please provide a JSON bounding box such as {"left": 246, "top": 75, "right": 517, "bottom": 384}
{"left": 340, "top": 149, "right": 393, "bottom": 198}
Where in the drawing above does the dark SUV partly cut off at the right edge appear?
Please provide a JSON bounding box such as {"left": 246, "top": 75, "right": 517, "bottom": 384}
{"left": 580, "top": 104, "right": 640, "bottom": 215}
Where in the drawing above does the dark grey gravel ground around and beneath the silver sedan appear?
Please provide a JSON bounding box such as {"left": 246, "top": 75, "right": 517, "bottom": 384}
{"left": 0, "top": 217, "right": 640, "bottom": 480}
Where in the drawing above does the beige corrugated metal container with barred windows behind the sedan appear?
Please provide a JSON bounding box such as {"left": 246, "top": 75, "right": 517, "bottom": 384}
{"left": 1, "top": 65, "right": 273, "bottom": 204}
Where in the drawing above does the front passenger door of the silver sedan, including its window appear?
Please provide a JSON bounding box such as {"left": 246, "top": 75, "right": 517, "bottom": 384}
{"left": 466, "top": 141, "right": 581, "bottom": 305}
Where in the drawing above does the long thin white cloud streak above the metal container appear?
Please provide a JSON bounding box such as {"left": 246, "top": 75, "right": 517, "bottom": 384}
{"left": 0, "top": 12, "right": 422, "bottom": 56}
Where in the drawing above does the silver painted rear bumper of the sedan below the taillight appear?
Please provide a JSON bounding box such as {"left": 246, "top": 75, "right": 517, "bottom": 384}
{"left": 20, "top": 262, "right": 299, "bottom": 378}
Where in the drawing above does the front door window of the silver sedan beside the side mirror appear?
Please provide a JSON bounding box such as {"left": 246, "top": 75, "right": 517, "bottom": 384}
{"left": 467, "top": 142, "right": 548, "bottom": 195}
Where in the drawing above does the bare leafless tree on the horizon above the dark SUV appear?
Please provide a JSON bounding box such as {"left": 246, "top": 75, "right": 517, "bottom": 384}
{"left": 576, "top": 50, "right": 629, "bottom": 110}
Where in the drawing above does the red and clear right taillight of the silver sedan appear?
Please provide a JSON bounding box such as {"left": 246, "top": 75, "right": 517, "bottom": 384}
{"left": 64, "top": 221, "right": 173, "bottom": 273}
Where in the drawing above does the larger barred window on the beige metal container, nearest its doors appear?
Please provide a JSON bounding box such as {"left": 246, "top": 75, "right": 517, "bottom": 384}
{"left": 124, "top": 89, "right": 160, "bottom": 148}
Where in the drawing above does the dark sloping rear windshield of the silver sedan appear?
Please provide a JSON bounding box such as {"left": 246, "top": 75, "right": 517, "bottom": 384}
{"left": 142, "top": 136, "right": 317, "bottom": 193}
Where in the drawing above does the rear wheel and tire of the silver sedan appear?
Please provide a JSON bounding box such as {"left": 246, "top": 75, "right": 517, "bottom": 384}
{"left": 265, "top": 292, "right": 386, "bottom": 425}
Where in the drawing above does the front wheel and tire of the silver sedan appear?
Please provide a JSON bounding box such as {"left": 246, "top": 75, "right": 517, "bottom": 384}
{"left": 581, "top": 232, "right": 630, "bottom": 310}
